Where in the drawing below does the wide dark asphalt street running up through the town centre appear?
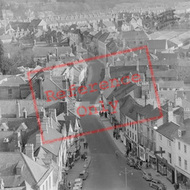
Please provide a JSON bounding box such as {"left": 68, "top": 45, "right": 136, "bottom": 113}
{"left": 81, "top": 58, "right": 150, "bottom": 190}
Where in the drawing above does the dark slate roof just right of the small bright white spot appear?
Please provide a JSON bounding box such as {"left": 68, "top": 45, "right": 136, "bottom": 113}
{"left": 156, "top": 122, "right": 179, "bottom": 140}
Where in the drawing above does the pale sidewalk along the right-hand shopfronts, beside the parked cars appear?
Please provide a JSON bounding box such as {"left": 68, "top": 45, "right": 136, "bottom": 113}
{"left": 100, "top": 117, "right": 174, "bottom": 190}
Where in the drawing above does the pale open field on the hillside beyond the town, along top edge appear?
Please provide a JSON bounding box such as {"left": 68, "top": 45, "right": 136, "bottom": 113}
{"left": 0, "top": 0, "right": 190, "bottom": 14}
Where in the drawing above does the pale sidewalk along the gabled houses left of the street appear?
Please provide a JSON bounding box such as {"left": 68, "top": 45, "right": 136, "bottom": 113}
{"left": 67, "top": 137, "right": 91, "bottom": 189}
